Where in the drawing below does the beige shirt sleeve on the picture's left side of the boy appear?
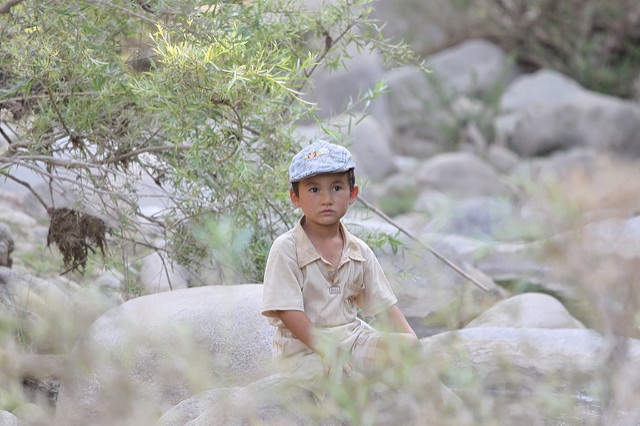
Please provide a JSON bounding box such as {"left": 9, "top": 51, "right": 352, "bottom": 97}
{"left": 262, "top": 234, "right": 304, "bottom": 326}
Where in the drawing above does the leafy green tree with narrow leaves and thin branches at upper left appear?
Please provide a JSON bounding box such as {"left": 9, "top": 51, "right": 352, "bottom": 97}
{"left": 0, "top": 0, "right": 412, "bottom": 286}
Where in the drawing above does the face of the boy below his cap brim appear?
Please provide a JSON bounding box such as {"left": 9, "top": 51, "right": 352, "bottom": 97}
{"left": 289, "top": 172, "right": 358, "bottom": 225}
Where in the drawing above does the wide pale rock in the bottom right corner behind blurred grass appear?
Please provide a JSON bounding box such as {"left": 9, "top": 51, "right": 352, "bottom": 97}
{"left": 422, "top": 327, "right": 640, "bottom": 424}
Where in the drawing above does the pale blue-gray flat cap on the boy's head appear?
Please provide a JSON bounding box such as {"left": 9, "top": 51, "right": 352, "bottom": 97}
{"left": 289, "top": 140, "right": 356, "bottom": 182}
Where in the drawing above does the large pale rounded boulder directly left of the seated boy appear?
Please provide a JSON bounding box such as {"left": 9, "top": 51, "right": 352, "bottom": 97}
{"left": 57, "top": 284, "right": 273, "bottom": 425}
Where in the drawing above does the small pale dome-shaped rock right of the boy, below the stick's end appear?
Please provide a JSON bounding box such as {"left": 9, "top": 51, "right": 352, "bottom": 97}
{"left": 465, "top": 293, "right": 585, "bottom": 329}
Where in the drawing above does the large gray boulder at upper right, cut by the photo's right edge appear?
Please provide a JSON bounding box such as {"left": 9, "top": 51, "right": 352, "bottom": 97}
{"left": 496, "top": 70, "right": 640, "bottom": 157}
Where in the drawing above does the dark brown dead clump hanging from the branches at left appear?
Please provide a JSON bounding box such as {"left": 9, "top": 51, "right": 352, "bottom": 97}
{"left": 47, "top": 207, "right": 107, "bottom": 271}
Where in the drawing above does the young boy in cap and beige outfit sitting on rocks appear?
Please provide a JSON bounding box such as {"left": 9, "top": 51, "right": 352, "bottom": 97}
{"left": 262, "top": 140, "right": 418, "bottom": 399}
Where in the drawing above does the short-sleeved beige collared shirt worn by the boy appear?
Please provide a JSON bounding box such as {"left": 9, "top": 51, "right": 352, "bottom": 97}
{"left": 262, "top": 218, "right": 397, "bottom": 356}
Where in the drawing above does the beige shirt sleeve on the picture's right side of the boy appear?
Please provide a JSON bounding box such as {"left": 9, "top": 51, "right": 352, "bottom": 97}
{"left": 356, "top": 242, "right": 398, "bottom": 316}
